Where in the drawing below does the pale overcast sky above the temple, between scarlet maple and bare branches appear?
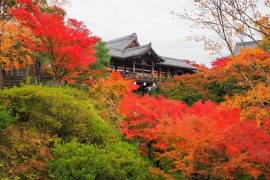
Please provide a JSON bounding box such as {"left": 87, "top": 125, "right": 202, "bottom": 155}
{"left": 65, "top": 0, "right": 266, "bottom": 66}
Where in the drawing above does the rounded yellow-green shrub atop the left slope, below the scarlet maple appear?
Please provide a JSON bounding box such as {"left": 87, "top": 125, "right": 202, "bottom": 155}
{"left": 0, "top": 86, "right": 117, "bottom": 144}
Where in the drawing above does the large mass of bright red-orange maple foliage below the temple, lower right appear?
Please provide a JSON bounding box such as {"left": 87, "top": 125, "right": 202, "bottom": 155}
{"left": 119, "top": 94, "right": 270, "bottom": 178}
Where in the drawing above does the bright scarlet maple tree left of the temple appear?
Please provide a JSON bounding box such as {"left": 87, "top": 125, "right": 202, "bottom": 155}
{"left": 10, "top": 0, "right": 99, "bottom": 84}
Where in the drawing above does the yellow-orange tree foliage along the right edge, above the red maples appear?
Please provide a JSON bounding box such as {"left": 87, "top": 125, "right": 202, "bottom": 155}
{"left": 217, "top": 49, "right": 270, "bottom": 126}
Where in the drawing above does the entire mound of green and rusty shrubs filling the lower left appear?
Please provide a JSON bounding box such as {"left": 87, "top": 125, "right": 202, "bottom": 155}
{"left": 0, "top": 86, "right": 149, "bottom": 179}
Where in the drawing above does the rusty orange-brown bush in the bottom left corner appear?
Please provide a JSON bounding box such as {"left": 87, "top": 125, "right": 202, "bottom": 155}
{"left": 0, "top": 123, "right": 52, "bottom": 179}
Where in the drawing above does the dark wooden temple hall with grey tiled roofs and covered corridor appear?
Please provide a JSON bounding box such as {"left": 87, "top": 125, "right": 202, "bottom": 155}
{"left": 106, "top": 33, "right": 196, "bottom": 90}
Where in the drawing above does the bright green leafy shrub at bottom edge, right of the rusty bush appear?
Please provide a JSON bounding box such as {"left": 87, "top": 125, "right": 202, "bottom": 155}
{"left": 49, "top": 141, "right": 149, "bottom": 180}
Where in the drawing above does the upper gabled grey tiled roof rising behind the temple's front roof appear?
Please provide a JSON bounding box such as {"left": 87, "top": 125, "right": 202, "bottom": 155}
{"left": 106, "top": 33, "right": 139, "bottom": 50}
